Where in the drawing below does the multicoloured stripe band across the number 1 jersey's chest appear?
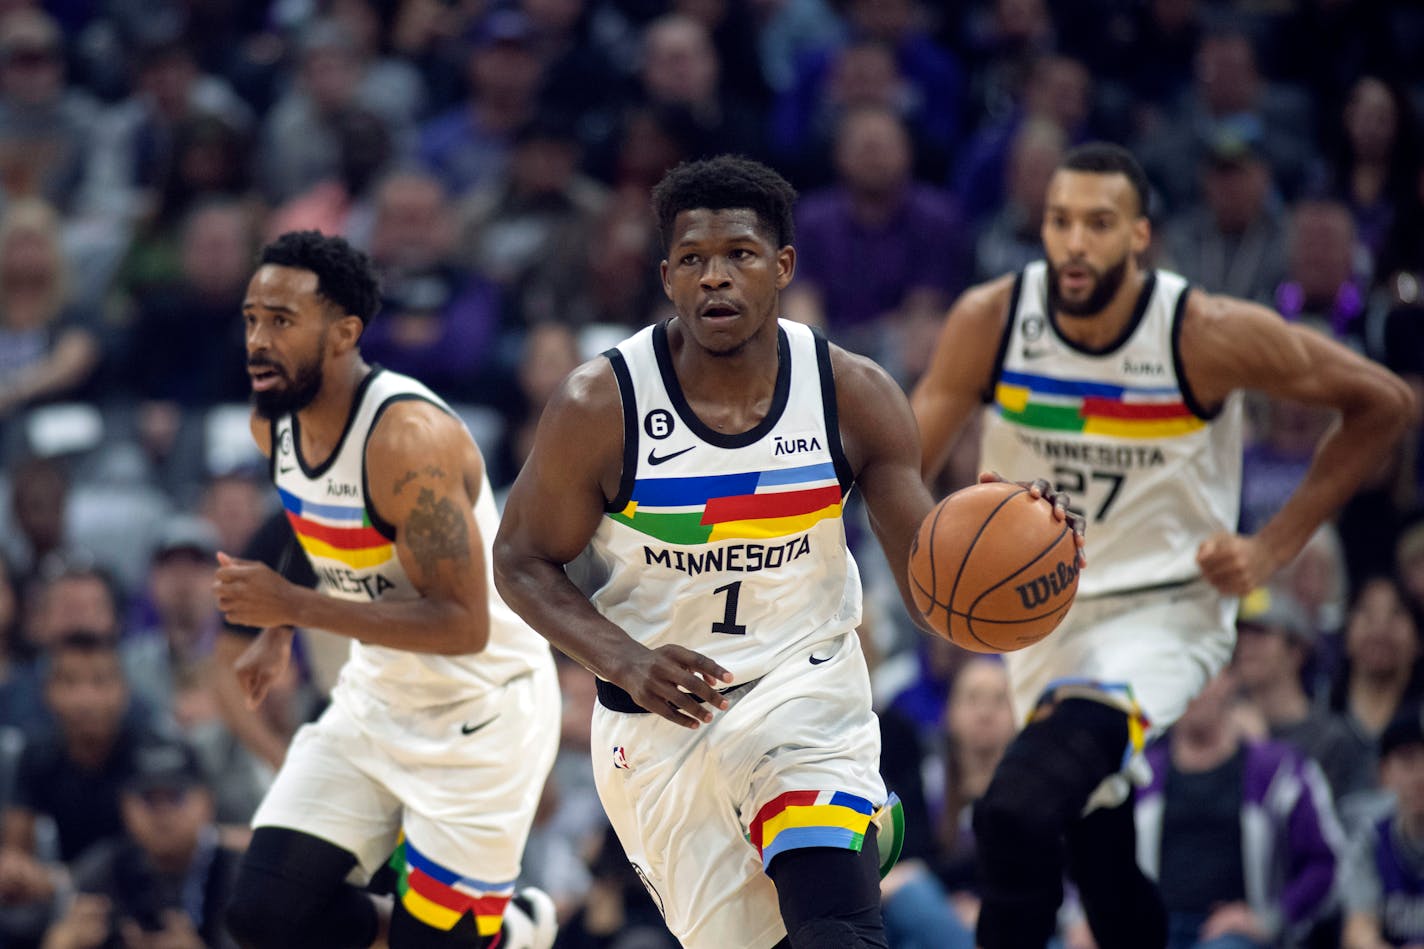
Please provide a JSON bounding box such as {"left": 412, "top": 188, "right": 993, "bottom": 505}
{"left": 609, "top": 462, "right": 842, "bottom": 544}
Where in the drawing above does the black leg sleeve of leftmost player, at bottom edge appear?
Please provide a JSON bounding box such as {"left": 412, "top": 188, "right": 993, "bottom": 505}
{"left": 226, "top": 826, "right": 379, "bottom": 949}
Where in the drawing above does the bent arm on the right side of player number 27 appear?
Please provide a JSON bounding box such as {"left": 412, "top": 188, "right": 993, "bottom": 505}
{"left": 1180, "top": 294, "right": 1418, "bottom": 594}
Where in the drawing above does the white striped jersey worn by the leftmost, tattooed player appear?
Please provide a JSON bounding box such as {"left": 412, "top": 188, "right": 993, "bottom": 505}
{"left": 272, "top": 369, "right": 550, "bottom": 708}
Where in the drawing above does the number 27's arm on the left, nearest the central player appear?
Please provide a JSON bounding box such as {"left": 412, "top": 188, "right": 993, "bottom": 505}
{"left": 910, "top": 276, "right": 1014, "bottom": 482}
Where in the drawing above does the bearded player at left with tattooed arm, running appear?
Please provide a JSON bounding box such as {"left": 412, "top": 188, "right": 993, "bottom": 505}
{"left": 216, "top": 231, "right": 560, "bottom": 949}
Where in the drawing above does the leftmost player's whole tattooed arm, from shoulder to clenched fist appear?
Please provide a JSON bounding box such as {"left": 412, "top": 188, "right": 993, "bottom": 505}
{"left": 216, "top": 400, "right": 490, "bottom": 655}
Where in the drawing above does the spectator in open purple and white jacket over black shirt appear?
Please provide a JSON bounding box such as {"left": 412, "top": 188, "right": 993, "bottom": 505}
{"left": 1136, "top": 670, "right": 1343, "bottom": 949}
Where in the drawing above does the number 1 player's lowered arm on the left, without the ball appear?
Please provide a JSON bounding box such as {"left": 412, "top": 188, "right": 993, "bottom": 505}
{"left": 494, "top": 359, "right": 731, "bottom": 728}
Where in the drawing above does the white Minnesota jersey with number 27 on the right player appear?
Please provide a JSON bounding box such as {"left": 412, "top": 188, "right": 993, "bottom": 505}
{"left": 980, "top": 261, "right": 1242, "bottom": 597}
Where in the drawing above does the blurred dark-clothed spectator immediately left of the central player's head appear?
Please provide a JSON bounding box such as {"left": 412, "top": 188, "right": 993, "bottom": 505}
{"left": 460, "top": 115, "right": 608, "bottom": 326}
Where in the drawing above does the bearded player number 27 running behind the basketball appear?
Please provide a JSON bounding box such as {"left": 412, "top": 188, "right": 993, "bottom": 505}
{"left": 911, "top": 144, "right": 1415, "bottom": 949}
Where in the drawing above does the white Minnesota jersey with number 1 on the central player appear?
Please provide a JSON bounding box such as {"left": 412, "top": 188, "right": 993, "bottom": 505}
{"left": 574, "top": 321, "right": 860, "bottom": 683}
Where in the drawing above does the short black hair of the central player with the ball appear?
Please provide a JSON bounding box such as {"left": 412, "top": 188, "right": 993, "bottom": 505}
{"left": 652, "top": 155, "right": 796, "bottom": 251}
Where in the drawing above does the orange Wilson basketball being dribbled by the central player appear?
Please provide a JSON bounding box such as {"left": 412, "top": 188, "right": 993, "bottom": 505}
{"left": 910, "top": 482, "right": 1078, "bottom": 653}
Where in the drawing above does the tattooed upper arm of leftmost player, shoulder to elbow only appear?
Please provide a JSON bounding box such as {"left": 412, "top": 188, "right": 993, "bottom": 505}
{"left": 366, "top": 399, "right": 490, "bottom": 651}
